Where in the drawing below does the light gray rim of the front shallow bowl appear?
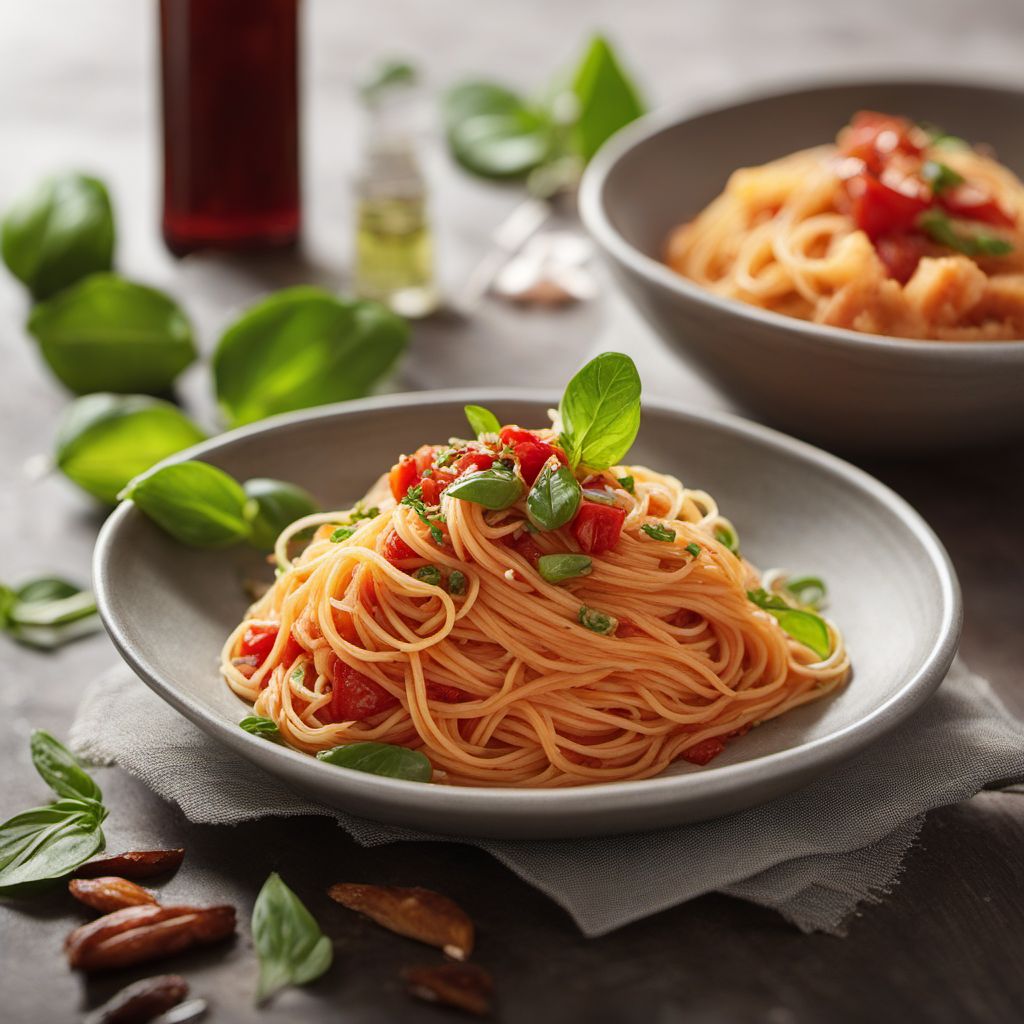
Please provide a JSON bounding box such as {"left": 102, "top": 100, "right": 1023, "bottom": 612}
{"left": 93, "top": 387, "right": 963, "bottom": 819}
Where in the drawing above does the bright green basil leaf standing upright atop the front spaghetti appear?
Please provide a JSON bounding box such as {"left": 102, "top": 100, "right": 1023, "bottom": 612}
{"left": 558, "top": 352, "right": 640, "bottom": 469}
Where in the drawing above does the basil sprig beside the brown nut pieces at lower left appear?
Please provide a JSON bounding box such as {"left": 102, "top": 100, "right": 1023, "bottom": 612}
{"left": 0, "top": 732, "right": 106, "bottom": 896}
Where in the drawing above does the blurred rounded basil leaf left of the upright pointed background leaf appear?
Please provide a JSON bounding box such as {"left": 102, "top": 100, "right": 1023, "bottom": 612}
{"left": 442, "top": 81, "right": 554, "bottom": 178}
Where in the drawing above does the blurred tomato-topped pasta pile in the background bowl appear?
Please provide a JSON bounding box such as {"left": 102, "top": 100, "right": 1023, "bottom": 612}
{"left": 666, "top": 112, "right": 1024, "bottom": 341}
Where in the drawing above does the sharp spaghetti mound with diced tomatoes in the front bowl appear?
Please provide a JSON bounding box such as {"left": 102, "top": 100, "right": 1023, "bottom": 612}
{"left": 222, "top": 364, "right": 849, "bottom": 786}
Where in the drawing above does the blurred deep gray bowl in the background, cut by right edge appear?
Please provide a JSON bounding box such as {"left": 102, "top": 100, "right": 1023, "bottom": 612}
{"left": 580, "top": 75, "right": 1024, "bottom": 453}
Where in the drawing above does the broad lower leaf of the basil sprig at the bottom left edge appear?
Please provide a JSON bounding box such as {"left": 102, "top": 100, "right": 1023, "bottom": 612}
{"left": 0, "top": 800, "right": 106, "bottom": 896}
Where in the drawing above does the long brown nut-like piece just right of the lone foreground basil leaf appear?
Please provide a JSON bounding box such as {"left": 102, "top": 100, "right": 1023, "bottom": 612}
{"left": 327, "top": 883, "right": 473, "bottom": 961}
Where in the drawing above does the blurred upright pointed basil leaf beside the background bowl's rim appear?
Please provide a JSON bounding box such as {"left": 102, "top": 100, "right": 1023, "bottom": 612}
{"left": 572, "top": 36, "right": 645, "bottom": 161}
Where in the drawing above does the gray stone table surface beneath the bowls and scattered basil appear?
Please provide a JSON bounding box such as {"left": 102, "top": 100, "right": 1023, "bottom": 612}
{"left": 0, "top": 0, "right": 1024, "bottom": 1024}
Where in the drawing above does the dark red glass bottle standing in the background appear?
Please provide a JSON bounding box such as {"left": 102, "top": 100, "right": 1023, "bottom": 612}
{"left": 160, "top": 0, "right": 301, "bottom": 256}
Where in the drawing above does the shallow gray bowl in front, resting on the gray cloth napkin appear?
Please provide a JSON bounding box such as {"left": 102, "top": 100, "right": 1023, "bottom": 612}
{"left": 94, "top": 391, "right": 961, "bottom": 839}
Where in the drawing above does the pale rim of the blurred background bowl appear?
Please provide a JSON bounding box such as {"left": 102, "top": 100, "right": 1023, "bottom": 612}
{"left": 578, "top": 75, "right": 1024, "bottom": 364}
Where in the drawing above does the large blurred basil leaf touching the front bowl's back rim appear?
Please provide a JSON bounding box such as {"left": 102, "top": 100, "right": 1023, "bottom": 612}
{"left": 213, "top": 286, "right": 409, "bottom": 427}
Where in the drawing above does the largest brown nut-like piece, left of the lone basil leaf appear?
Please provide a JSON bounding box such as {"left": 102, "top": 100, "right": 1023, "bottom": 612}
{"left": 65, "top": 903, "right": 234, "bottom": 971}
